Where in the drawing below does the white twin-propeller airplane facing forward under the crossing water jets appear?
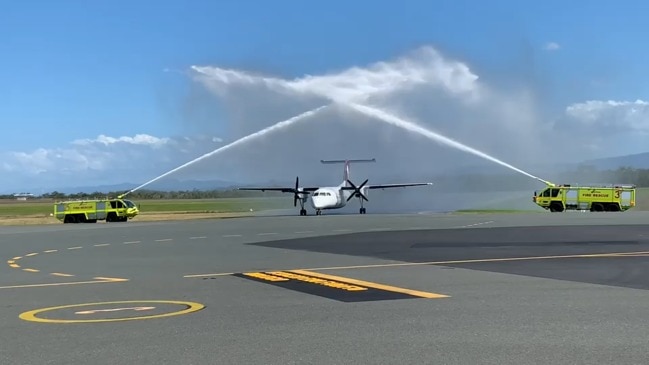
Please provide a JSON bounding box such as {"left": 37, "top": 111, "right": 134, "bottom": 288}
{"left": 239, "top": 158, "right": 433, "bottom": 216}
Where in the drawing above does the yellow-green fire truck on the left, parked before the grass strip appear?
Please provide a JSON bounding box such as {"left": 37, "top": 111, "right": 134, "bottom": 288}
{"left": 54, "top": 197, "right": 140, "bottom": 223}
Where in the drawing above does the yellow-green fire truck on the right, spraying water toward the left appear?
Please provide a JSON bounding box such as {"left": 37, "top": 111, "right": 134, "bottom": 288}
{"left": 532, "top": 183, "right": 636, "bottom": 212}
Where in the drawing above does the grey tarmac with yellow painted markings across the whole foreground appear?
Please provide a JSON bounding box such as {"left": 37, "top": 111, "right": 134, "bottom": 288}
{"left": 0, "top": 211, "right": 649, "bottom": 364}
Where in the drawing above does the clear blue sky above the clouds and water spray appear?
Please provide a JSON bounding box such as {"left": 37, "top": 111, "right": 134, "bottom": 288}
{"left": 0, "top": 0, "right": 649, "bottom": 192}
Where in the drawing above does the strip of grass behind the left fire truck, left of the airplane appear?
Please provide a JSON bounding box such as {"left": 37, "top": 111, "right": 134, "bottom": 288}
{"left": 0, "top": 195, "right": 293, "bottom": 217}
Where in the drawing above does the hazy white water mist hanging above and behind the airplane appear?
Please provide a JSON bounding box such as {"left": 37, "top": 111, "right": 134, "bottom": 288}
{"left": 159, "top": 47, "right": 636, "bottom": 211}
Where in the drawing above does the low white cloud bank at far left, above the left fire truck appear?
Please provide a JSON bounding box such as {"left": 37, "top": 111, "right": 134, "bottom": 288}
{"left": 0, "top": 134, "right": 222, "bottom": 190}
